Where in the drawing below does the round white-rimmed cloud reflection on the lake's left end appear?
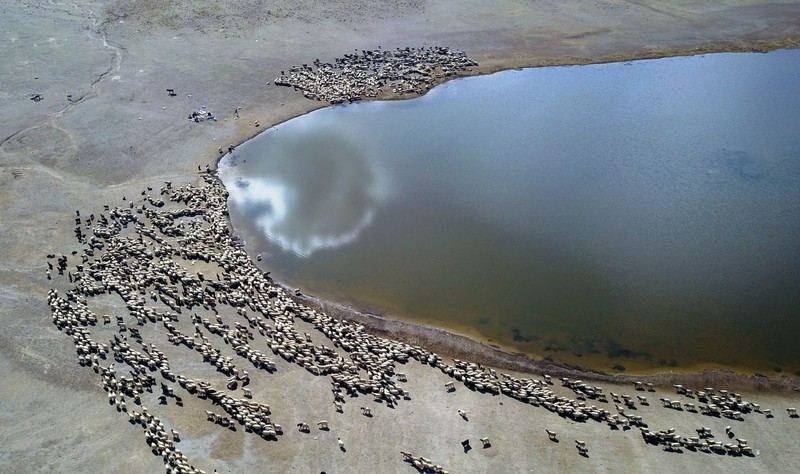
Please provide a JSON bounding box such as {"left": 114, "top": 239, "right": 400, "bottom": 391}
{"left": 222, "top": 130, "right": 386, "bottom": 258}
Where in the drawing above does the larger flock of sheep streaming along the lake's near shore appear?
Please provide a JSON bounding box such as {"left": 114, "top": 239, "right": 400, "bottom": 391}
{"left": 47, "top": 171, "right": 797, "bottom": 472}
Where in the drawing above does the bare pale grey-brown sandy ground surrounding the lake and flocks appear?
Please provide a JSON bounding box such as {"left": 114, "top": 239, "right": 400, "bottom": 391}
{"left": 0, "top": 0, "right": 800, "bottom": 472}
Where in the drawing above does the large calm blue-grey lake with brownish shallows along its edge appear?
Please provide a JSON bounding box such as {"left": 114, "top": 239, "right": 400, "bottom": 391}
{"left": 220, "top": 50, "right": 800, "bottom": 375}
